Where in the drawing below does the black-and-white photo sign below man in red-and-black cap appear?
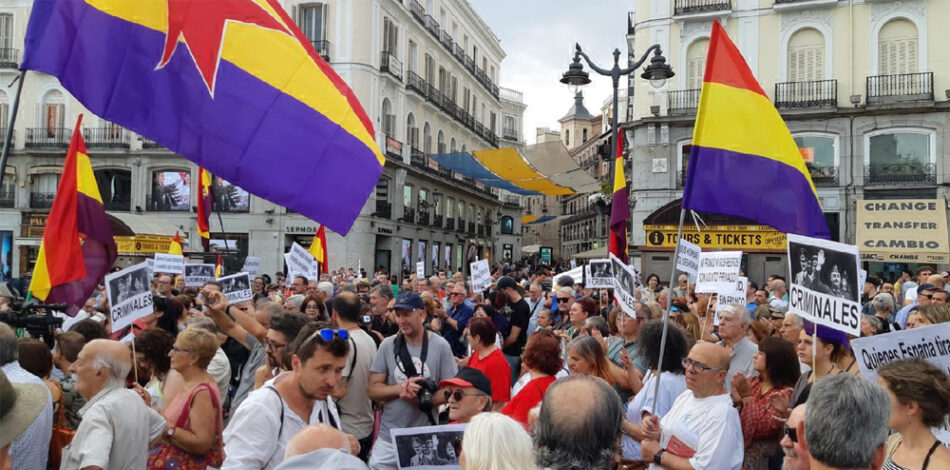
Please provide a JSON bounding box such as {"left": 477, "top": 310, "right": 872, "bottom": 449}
{"left": 391, "top": 424, "right": 465, "bottom": 470}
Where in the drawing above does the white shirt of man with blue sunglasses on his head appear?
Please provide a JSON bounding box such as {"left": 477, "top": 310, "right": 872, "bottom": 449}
{"left": 221, "top": 372, "right": 340, "bottom": 470}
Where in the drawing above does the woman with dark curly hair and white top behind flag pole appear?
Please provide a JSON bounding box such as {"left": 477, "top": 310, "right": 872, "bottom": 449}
{"left": 621, "top": 319, "right": 689, "bottom": 462}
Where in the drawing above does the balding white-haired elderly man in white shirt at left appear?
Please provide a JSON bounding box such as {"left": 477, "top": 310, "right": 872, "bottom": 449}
{"left": 60, "top": 339, "right": 165, "bottom": 470}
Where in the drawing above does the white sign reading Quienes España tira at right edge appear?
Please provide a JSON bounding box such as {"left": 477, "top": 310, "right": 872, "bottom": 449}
{"left": 851, "top": 323, "right": 950, "bottom": 383}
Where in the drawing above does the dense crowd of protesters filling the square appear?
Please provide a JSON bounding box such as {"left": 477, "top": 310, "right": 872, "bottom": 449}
{"left": 0, "top": 260, "right": 950, "bottom": 470}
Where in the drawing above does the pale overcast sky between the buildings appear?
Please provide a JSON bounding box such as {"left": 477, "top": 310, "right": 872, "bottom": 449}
{"left": 469, "top": 0, "right": 634, "bottom": 143}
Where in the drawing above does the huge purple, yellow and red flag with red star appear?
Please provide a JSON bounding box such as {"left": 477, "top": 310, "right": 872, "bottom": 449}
{"left": 22, "top": 0, "right": 384, "bottom": 234}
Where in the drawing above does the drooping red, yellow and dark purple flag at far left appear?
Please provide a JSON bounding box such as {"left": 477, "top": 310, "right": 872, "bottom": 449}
{"left": 30, "top": 115, "right": 117, "bottom": 316}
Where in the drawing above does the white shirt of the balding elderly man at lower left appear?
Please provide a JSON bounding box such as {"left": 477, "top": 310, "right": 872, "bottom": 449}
{"left": 60, "top": 387, "right": 165, "bottom": 470}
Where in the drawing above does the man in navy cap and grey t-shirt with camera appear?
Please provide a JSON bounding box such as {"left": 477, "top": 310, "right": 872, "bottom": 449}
{"left": 369, "top": 292, "right": 458, "bottom": 470}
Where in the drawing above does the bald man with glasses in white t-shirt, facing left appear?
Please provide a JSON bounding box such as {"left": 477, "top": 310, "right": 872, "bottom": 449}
{"left": 642, "top": 342, "right": 743, "bottom": 470}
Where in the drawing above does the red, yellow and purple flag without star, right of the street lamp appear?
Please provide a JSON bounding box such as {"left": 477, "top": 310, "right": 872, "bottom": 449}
{"left": 680, "top": 21, "right": 829, "bottom": 238}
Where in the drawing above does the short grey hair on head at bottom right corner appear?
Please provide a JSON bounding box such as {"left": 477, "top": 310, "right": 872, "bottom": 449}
{"left": 805, "top": 374, "right": 891, "bottom": 468}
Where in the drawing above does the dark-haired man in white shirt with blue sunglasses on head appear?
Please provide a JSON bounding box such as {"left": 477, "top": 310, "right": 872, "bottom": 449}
{"left": 221, "top": 322, "right": 359, "bottom": 470}
